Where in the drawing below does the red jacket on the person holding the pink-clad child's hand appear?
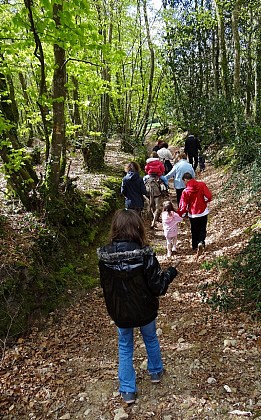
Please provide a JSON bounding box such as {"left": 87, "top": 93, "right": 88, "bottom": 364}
{"left": 177, "top": 179, "right": 212, "bottom": 218}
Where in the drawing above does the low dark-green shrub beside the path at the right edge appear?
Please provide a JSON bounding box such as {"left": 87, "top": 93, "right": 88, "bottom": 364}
{"left": 201, "top": 233, "right": 261, "bottom": 316}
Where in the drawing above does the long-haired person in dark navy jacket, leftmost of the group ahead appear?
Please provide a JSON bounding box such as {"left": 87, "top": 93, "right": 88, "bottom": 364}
{"left": 121, "top": 162, "right": 147, "bottom": 214}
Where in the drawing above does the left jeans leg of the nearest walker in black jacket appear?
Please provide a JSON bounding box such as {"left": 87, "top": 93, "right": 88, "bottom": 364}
{"left": 118, "top": 328, "right": 136, "bottom": 392}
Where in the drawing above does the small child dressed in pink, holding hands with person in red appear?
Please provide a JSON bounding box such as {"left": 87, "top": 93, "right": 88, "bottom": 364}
{"left": 161, "top": 201, "right": 183, "bottom": 257}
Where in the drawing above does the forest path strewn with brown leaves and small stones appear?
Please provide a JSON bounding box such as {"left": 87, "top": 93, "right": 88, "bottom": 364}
{"left": 0, "top": 139, "right": 261, "bottom": 420}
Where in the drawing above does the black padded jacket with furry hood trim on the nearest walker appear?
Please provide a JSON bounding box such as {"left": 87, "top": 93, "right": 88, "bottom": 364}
{"left": 97, "top": 241, "right": 176, "bottom": 328}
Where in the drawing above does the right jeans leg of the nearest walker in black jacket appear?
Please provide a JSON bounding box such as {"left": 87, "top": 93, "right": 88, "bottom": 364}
{"left": 140, "top": 320, "right": 163, "bottom": 373}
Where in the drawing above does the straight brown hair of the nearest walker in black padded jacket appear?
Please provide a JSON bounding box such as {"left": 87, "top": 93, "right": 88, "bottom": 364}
{"left": 110, "top": 209, "right": 146, "bottom": 246}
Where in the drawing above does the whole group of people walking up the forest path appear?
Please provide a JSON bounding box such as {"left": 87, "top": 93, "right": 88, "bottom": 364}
{"left": 97, "top": 133, "right": 212, "bottom": 404}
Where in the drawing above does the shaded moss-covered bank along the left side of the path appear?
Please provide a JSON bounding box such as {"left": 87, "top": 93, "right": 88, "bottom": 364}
{"left": 0, "top": 177, "right": 121, "bottom": 341}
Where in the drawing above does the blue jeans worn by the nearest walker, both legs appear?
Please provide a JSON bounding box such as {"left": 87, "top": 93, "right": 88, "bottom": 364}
{"left": 118, "top": 320, "right": 163, "bottom": 392}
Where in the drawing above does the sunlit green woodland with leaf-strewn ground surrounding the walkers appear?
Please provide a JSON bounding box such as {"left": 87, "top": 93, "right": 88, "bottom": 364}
{"left": 0, "top": 0, "right": 261, "bottom": 420}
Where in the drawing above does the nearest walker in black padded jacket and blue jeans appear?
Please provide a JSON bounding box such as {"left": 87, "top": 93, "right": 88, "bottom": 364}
{"left": 97, "top": 209, "right": 177, "bottom": 404}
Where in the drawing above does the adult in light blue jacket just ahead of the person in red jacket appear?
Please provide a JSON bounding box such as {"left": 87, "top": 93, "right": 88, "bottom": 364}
{"left": 165, "top": 153, "right": 195, "bottom": 206}
